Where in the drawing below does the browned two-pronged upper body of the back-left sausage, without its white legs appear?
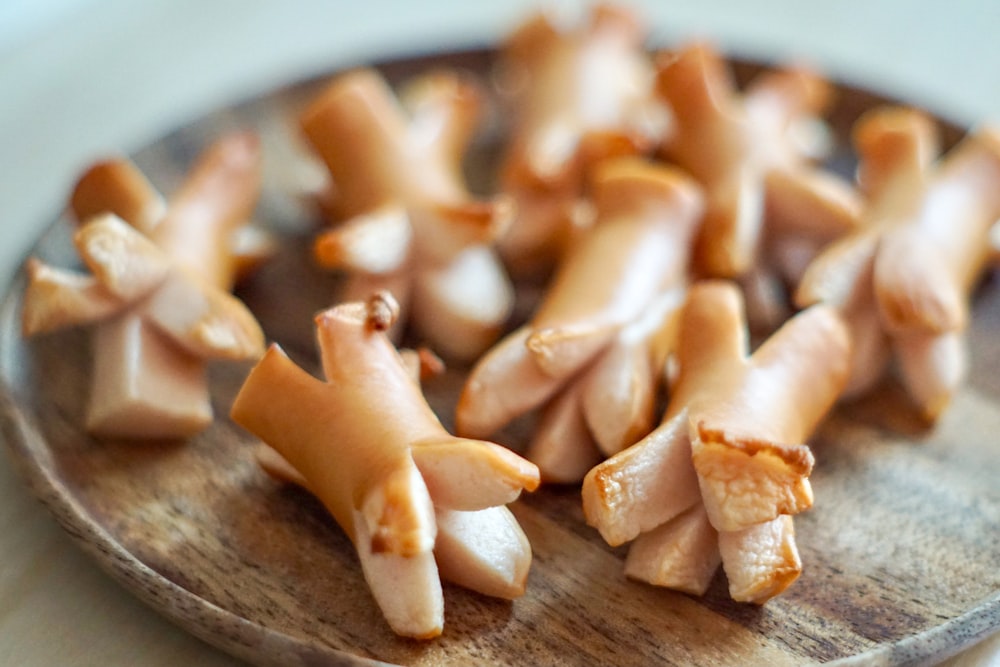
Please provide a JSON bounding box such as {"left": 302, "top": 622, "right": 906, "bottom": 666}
{"left": 302, "top": 69, "right": 512, "bottom": 262}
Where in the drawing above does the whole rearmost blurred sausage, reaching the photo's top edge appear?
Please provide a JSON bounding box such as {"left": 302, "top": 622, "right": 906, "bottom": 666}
{"left": 498, "top": 4, "right": 669, "bottom": 275}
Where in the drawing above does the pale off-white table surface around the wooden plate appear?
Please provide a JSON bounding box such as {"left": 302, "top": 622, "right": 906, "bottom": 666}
{"left": 0, "top": 0, "right": 1000, "bottom": 667}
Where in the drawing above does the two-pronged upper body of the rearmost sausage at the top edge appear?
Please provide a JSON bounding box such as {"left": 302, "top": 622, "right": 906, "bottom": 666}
{"left": 501, "top": 5, "right": 663, "bottom": 194}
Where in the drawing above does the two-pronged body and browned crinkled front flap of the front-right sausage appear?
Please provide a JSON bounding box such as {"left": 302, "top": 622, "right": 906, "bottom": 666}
{"left": 667, "top": 283, "right": 850, "bottom": 531}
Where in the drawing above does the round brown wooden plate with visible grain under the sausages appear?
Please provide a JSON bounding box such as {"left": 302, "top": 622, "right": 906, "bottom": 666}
{"left": 0, "top": 51, "right": 1000, "bottom": 666}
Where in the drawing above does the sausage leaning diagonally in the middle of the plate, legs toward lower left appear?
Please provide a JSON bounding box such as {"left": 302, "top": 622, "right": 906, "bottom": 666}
{"left": 456, "top": 158, "right": 701, "bottom": 482}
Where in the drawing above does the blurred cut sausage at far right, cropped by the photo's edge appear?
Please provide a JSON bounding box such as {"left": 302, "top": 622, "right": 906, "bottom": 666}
{"left": 796, "top": 107, "right": 1000, "bottom": 414}
